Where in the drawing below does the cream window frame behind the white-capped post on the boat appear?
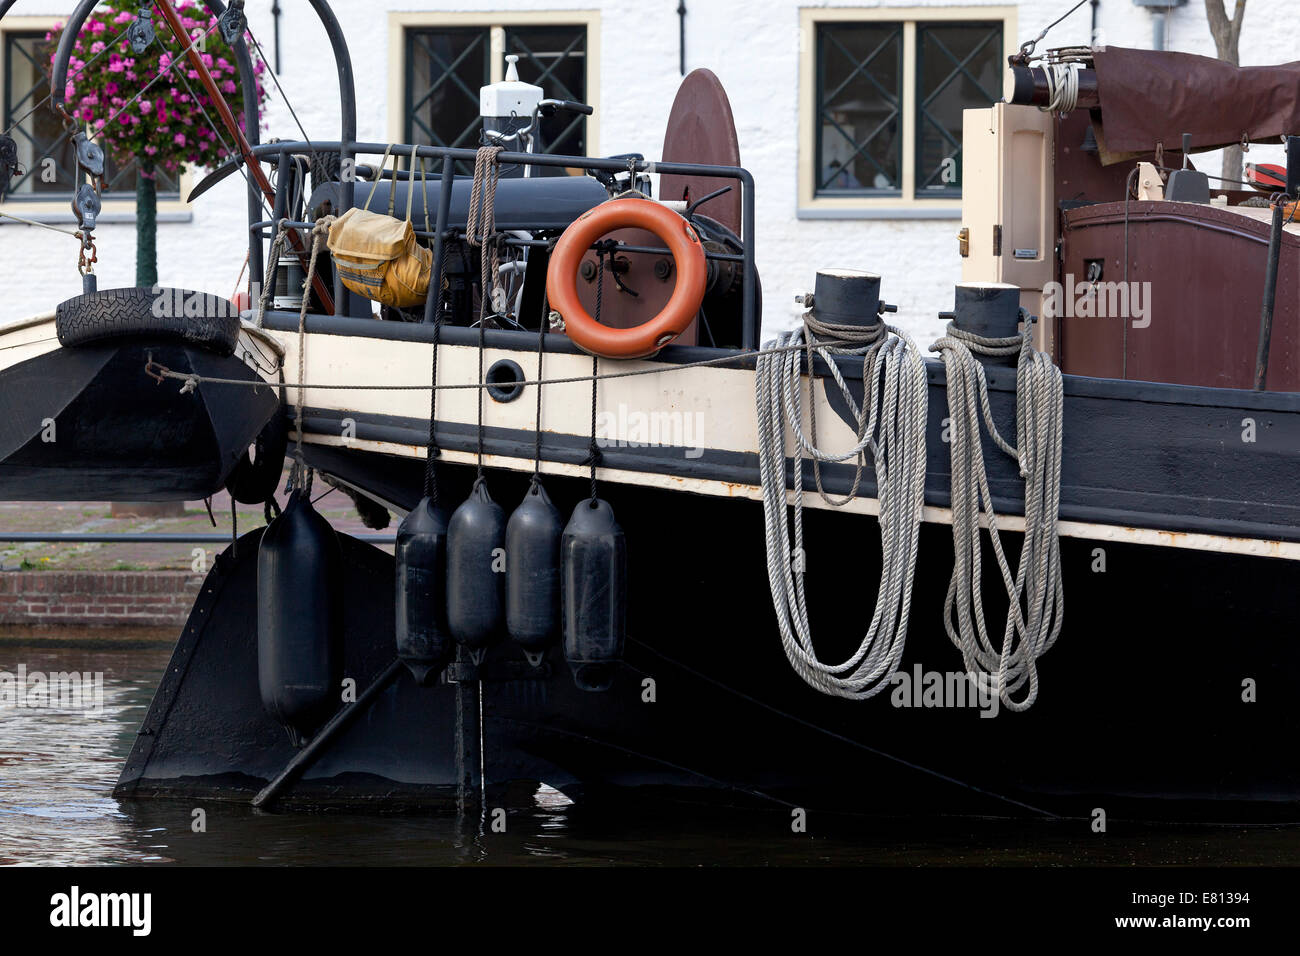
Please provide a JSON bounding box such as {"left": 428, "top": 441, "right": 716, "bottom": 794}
{"left": 387, "top": 9, "right": 601, "bottom": 155}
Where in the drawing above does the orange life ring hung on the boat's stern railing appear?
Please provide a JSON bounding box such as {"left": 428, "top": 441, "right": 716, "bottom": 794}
{"left": 546, "top": 196, "right": 707, "bottom": 359}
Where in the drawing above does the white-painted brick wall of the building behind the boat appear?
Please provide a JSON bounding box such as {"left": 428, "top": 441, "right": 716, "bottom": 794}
{"left": 0, "top": 0, "right": 1295, "bottom": 342}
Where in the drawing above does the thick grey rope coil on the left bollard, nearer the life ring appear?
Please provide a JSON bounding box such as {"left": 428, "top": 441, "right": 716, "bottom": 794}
{"left": 755, "top": 316, "right": 927, "bottom": 700}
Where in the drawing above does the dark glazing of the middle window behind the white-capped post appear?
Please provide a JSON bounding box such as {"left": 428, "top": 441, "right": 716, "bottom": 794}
{"left": 402, "top": 14, "right": 589, "bottom": 176}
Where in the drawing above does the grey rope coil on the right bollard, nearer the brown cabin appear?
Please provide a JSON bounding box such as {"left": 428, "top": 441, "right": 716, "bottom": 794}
{"left": 931, "top": 321, "right": 1065, "bottom": 710}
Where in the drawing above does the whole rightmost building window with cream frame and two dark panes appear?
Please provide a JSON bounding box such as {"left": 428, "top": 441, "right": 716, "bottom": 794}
{"left": 800, "top": 7, "right": 1015, "bottom": 216}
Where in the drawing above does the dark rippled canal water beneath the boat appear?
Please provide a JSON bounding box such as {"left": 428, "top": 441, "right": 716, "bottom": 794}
{"left": 0, "top": 639, "right": 1300, "bottom": 866}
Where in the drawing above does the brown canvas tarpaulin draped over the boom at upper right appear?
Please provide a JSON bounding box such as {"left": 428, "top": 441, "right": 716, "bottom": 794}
{"left": 1093, "top": 47, "right": 1300, "bottom": 153}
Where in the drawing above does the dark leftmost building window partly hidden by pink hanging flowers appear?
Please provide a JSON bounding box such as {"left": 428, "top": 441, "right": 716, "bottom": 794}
{"left": 0, "top": 30, "right": 181, "bottom": 202}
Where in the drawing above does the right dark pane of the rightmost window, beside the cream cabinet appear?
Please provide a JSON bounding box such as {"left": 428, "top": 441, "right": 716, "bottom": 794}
{"left": 917, "top": 22, "right": 1002, "bottom": 199}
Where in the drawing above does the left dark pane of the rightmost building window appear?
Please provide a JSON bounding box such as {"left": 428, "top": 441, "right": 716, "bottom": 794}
{"left": 814, "top": 23, "right": 902, "bottom": 195}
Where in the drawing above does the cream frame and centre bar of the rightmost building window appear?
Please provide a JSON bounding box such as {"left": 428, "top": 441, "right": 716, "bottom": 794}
{"left": 797, "top": 4, "right": 1019, "bottom": 220}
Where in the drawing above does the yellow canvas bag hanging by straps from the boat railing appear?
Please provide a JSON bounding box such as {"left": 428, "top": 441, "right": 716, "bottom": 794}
{"left": 326, "top": 146, "right": 433, "bottom": 308}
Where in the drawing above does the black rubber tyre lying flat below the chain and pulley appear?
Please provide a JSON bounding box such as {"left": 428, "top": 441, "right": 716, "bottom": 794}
{"left": 55, "top": 286, "right": 239, "bottom": 355}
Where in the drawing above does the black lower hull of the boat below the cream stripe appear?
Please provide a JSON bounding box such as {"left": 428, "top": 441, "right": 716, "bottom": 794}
{"left": 117, "top": 457, "right": 1300, "bottom": 821}
